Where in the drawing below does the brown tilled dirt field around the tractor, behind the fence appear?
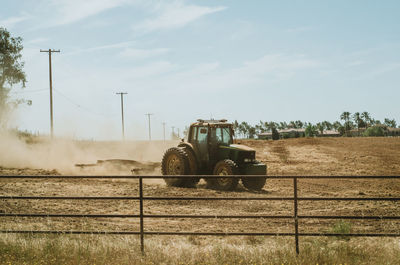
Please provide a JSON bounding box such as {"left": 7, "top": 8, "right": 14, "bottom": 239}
{"left": 0, "top": 138, "right": 400, "bottom": 235}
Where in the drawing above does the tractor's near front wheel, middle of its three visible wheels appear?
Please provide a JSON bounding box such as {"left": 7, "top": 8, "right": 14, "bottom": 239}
{"left": 207, "top": 159, "right": 239, "bottom": 190}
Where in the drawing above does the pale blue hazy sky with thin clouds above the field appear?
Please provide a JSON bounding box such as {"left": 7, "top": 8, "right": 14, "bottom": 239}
{"left": 0, "top": 0, "right": 400, "bottom": 140}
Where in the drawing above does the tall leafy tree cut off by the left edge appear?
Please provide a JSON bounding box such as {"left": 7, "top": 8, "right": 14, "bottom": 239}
{"left": 0, "top": 27, "right": 26, "bottom": 127}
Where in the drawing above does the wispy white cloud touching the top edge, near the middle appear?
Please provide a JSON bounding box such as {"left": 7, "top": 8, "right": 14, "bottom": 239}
{"left": 133, "top": 1, "right": 226, "bottom": 32}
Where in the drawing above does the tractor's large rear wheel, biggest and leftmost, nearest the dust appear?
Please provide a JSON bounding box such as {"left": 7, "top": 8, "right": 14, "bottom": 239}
{"left": 161, "top": 147, "right": 198, "bottom": 187}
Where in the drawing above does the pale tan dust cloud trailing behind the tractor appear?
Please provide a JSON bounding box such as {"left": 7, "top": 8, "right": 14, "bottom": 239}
{"left": 0, "top": 131, "right": 177, "bottom": 175}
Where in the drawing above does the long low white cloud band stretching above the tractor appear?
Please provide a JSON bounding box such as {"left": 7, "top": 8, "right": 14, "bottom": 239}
{"left": 125, "top": 54, "right": 321, "bottom": 95}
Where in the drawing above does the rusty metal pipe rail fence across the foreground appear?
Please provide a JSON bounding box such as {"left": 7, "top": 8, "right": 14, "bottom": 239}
{"left": 0, "top": 175, "right": 400, "bottom": 254}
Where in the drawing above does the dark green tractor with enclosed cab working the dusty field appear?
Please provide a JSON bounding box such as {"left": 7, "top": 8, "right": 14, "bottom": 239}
{"left": 161, "top": 119, "right": 267, "bottom": 191}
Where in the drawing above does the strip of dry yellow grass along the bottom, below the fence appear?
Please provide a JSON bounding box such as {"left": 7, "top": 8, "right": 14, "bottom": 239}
{"left": 0, "top": 234, "right": 400, "bottom": 264}
